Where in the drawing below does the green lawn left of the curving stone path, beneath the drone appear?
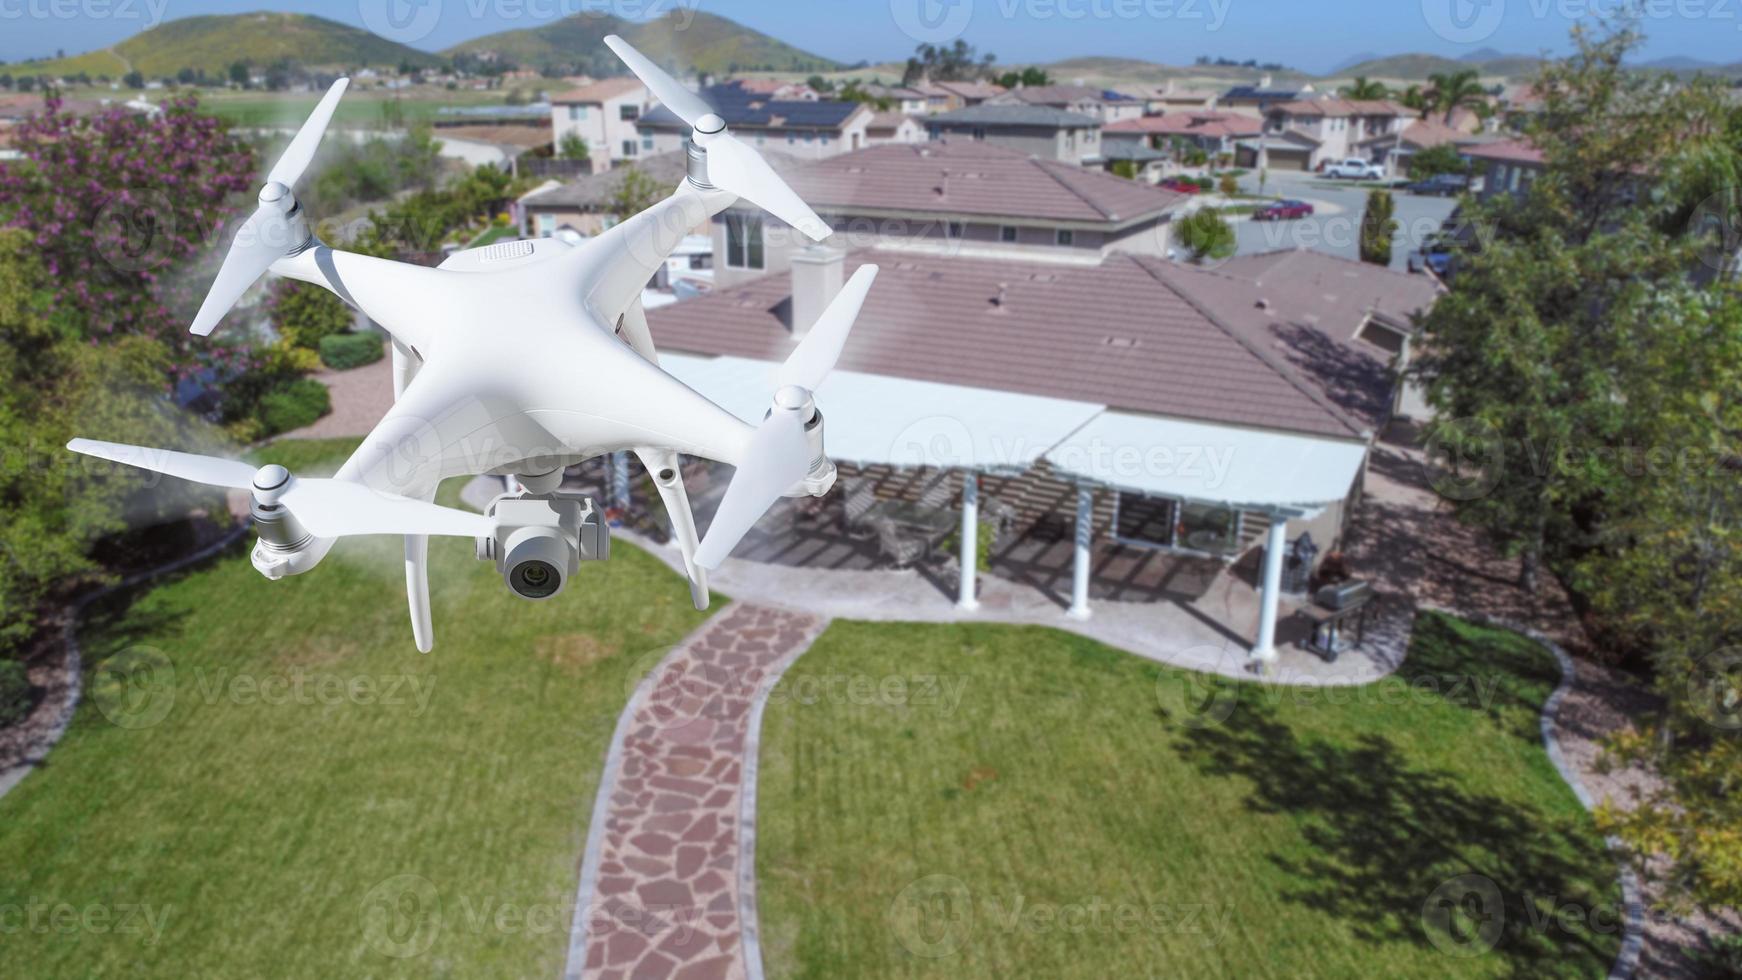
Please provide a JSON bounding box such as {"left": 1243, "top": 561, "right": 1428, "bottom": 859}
{"left": 0, "top": 440, "right": 704, "bottom": 977}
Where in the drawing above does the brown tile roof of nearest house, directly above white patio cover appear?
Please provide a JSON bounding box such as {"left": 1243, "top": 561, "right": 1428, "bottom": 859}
{"left": 648, "top": 249, "right": 1364, "bottom": 439}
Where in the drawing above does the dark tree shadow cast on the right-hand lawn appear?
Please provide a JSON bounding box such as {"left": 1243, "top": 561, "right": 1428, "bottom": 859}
{"left": 1174, "top": 616, "right": 1622, "bottom": 977}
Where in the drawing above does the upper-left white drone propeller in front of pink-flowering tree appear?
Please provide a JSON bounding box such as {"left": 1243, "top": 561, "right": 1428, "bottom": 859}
{"left": 190, "top": 78, "right": 350, "bottom": 336}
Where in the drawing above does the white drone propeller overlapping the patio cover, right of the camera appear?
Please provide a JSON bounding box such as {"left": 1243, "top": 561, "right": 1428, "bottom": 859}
{"left": 695, "top": 265, "right": 876, "bottom": 569}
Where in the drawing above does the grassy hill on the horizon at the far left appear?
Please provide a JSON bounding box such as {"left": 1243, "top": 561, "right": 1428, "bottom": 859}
{"left": 10, "top": 12, "right": 441, "bottom": 78}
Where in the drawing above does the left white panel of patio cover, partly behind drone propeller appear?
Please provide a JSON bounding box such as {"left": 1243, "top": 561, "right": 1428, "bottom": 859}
{"left": 658, "top": 353, "right": 1106, "bottom": 472}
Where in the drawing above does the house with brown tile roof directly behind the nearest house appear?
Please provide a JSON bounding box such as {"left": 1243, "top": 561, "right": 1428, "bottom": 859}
{"left": 712, "top": 141, "right": 1186, "bottom": 285}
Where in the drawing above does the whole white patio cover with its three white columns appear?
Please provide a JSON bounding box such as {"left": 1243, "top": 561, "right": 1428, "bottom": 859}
{"left": 660, "top": 353, "right": 1366, "bottom": 667}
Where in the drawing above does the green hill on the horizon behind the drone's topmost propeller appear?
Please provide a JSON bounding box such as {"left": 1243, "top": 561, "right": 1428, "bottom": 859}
{"left": 442, "top": 12, "right": 840, "bottom": 75}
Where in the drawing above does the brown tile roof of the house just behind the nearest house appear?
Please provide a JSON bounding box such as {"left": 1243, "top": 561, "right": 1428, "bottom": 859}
{"left": 787, "top": 139, "right": 1183, "bottom": 223}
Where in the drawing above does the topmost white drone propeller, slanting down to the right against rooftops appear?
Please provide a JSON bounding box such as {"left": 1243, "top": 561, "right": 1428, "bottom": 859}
{"left": 604, "top": 35, "right": 833, "bottom": 242}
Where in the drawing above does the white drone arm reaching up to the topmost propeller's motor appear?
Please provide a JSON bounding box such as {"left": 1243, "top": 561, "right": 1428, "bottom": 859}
{"left": 571, "top": 178, "right": 737, "bottom": 334}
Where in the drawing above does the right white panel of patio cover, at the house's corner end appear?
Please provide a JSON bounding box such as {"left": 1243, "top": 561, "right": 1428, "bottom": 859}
{"left": 1045, "top": 413, "right": 1367, "bottom": 515}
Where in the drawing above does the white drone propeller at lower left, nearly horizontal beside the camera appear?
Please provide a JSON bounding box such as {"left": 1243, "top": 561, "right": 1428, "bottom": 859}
{"left": 66, "top": 439, "right": 495, "bottom": 538}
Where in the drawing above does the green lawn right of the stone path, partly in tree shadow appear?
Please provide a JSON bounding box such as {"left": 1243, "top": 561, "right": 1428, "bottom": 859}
{"left": 758, "top": 614, "right": 1620, "bottom": 980}
